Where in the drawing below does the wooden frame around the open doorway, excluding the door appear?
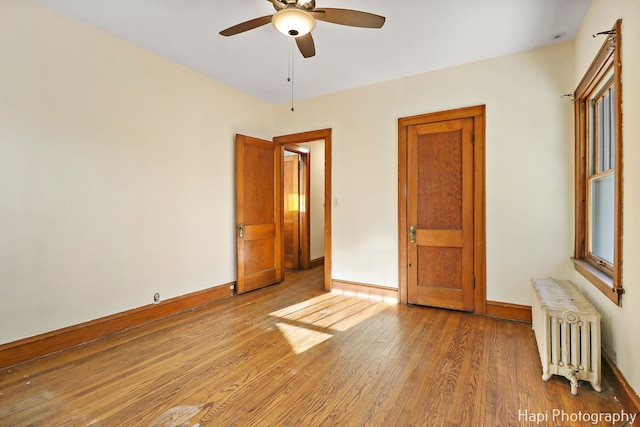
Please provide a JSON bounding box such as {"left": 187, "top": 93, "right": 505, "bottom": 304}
{"left": 273, "top": 128, "right": 331, "bottom": 291}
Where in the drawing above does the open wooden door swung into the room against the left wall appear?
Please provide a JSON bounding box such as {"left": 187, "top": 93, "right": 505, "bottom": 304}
{"left": 236, "top": 135, "right": 284, "bottom": 293}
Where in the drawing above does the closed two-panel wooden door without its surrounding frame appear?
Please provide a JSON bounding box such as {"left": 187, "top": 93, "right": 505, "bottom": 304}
{"left": 407, "top": 118, "right": 474, "bottom": 311}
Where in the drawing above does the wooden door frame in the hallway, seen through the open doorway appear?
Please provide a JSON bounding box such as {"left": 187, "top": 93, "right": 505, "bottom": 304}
{"left": 282, "top": 144, "right": 311, "bottom": 270}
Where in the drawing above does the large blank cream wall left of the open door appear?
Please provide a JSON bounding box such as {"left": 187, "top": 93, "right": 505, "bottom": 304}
{"left": 0, "top": 0, "right": 273, "bottom": 343}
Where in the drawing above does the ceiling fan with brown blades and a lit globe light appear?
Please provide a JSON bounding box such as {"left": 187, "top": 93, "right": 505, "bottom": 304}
{"left": 220, "top": 0, "right": 385, "bottom": 58}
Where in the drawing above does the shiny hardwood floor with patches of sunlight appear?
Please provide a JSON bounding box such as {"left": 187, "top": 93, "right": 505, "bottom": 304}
{"left": 0, "top": 268, "right": 637, "bottom": 426}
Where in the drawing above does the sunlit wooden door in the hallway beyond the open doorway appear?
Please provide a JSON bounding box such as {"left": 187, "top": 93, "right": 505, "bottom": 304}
{"left": 282, "top": 154, "right": 300, "bottom": 270}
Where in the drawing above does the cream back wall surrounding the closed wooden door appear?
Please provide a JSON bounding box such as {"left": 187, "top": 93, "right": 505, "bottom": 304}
{"left": 275, "top": 42, "right": 574, "bottom": 304}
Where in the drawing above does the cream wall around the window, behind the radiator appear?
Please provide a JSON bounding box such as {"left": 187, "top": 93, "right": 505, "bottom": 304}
{"left": 573, "top": 0, "right": 640, "bottom": 398}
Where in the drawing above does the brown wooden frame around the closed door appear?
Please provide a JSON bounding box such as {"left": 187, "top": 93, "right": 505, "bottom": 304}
{"left": 398, "top": 105, "right": 487, "bottom": 315}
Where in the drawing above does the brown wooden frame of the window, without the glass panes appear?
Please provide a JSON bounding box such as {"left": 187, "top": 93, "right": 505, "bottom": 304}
{"left": 572, "top": 20, "right": 624, "bottom": 305}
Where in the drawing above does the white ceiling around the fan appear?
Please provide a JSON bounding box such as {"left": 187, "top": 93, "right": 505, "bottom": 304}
{"left": 37, "top": 0, "right": 591, "bottom": 104}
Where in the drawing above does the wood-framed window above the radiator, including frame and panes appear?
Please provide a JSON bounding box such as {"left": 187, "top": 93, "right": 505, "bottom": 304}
{"left": 573, "top": 20, "right": 623, "bottom": 304}
